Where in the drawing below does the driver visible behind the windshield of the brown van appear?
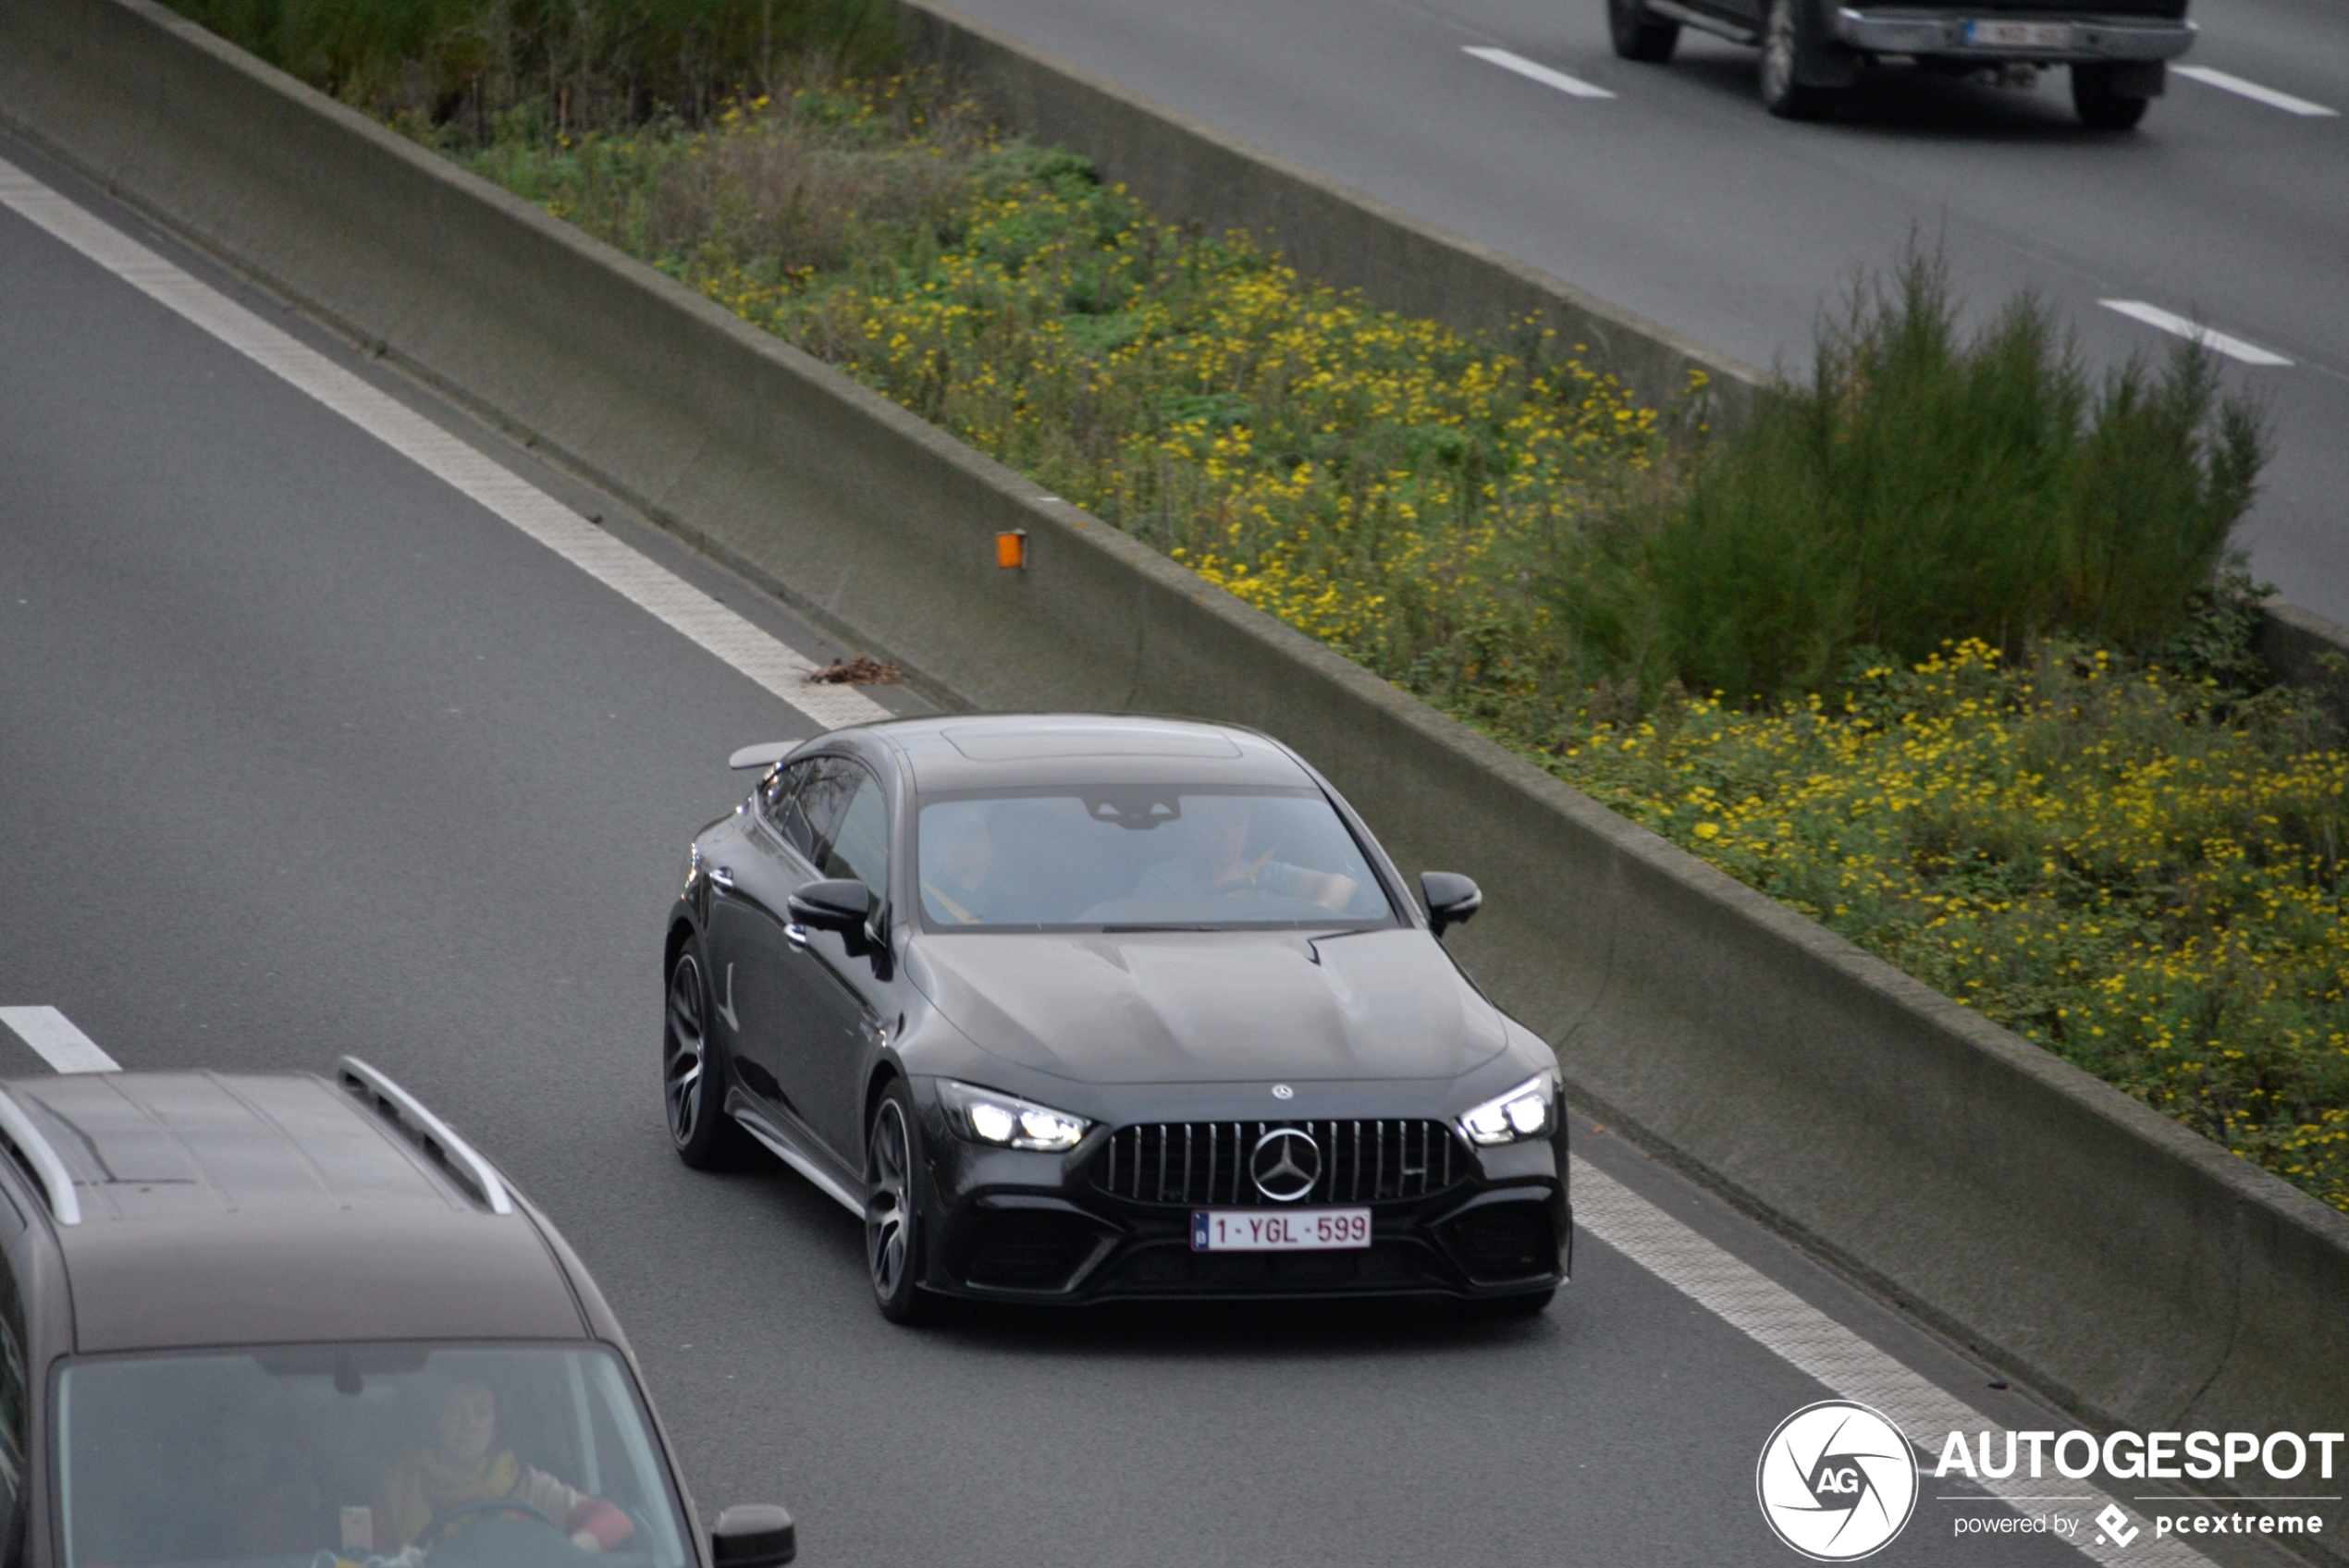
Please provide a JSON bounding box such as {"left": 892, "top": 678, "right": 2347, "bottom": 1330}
{"left": 375, "top": 1380, "right": 636, "bottom": 1551}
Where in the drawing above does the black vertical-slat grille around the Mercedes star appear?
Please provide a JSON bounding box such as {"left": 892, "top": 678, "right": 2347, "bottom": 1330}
{"left": 1092, "top": 1120, "right": 1469, "bottom": 1204}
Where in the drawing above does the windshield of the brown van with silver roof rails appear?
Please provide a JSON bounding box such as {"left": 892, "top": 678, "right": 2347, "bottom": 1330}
{"left": 56, "top": 1345, "right": 693, "bottom": 1568}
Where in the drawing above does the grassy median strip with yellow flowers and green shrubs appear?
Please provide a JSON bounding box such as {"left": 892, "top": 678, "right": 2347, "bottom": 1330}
{"left": 170, "top": 0, "right": 2349, "bottom": 1207}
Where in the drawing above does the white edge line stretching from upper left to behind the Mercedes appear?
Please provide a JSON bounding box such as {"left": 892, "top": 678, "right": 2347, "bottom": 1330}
{"left": 0, "top": 160, "right": 888, "bottom": 730}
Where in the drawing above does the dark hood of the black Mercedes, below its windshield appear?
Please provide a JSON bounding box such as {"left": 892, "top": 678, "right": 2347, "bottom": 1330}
{"left": 909, "top": 929, "right": 1504, "bottom": 1084}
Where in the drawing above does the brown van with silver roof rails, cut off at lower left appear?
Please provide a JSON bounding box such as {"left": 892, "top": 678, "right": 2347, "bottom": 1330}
{"left": 0, "top": 1059, "right": 796, "bottom": 1568}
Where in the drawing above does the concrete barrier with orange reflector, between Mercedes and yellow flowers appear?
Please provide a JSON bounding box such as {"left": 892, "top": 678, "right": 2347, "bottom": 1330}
{"left": 0, "top": 0, "right": 2349, "bottom": 1492}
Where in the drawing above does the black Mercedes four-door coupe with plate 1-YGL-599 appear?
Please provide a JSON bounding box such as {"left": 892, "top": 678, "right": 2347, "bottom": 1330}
{"left": 662, "top": 714, "right": 1569, "bottom": 1321}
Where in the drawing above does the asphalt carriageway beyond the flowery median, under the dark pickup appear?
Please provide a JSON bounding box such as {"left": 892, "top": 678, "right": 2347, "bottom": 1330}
{"left": 952, "top": 0, "right": 2349, "bottom": 622}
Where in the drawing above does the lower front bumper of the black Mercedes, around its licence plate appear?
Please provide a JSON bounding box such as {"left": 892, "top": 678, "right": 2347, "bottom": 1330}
{"left": 923, "top": 1089, "right": 1571, "bottom": 1305}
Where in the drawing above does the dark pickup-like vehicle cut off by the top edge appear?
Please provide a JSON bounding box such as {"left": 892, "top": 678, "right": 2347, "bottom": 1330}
{"left": 1606, "top": 0, "right": 2194, "bottom": 131}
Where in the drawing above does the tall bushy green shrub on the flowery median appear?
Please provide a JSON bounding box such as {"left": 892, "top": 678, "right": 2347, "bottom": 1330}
{"left": 1611, "top": 253, "right": 2265, "bottom": 702}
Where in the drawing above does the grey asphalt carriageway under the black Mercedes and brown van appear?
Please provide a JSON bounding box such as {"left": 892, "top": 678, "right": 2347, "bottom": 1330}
{"left": 0, "top": 141, "right": 2311, "bottom": 1568}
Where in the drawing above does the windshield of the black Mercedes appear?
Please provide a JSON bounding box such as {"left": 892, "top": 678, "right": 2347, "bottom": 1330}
{"left": 916, "top": 784, "right": 1393, "bottom": 929}
